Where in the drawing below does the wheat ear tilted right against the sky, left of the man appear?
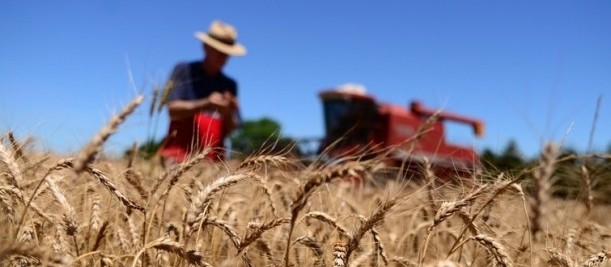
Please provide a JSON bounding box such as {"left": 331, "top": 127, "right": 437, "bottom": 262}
{"left": 74, "top": 95, "right": 144, "bottom": 173}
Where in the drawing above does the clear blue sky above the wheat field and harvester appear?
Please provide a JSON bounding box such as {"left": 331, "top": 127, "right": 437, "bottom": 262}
{"left": 0, "top": 0, "right": 611, "bottom": 158}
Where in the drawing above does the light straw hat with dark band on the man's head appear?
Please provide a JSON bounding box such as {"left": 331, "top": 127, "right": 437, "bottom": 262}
{"left": 195, "top": 20, "right": 246, "bottom": 56}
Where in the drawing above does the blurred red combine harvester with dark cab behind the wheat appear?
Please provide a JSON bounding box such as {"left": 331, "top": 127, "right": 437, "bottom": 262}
{"left": 319, "top": 86, "right": 484, "bottom": 175}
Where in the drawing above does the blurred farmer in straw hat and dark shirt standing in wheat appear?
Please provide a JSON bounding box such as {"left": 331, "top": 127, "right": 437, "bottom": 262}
{"left": 160, "top": 20, "right": 246, "bottom": 164}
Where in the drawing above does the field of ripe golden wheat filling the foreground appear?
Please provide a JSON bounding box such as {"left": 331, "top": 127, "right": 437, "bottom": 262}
{"left": 0, "top": 95, "right": 611, "bottom": 267}
